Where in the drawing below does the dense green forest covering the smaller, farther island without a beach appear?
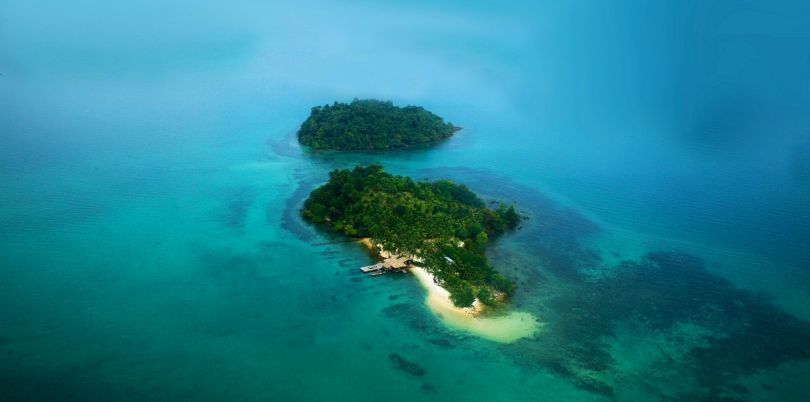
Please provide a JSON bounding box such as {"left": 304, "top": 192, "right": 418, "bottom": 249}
{"left": 298, "top": 99, "right": 458, "bottom": 150}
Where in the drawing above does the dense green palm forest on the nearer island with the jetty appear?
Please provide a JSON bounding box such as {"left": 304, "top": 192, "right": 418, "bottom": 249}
{"left": 302, "top": 165, "right": 521, "bottom": 306}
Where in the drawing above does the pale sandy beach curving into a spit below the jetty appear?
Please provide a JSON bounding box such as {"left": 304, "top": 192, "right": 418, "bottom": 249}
{"left": 359, "top": 238, "right": 541, "bottom": 343}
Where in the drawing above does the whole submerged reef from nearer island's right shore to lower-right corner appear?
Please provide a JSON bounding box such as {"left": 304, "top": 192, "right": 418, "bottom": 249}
{"left": 425, "top": 168, "right": 810, "bottom": 401}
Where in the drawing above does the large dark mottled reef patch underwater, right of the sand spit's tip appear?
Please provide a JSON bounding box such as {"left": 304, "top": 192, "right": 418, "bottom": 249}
{"left": 508, "top": 252, "right": 810, "bottom": 400}
